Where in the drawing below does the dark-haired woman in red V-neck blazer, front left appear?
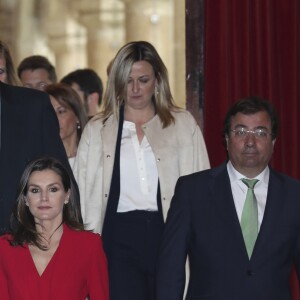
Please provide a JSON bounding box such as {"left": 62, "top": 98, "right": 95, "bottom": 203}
{"left": 0, "top": 158, "right": 109, "bottom": 300}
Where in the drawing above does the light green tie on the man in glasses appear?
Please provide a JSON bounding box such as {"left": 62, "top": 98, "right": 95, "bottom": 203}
{"left": 241, "top": 178, "right": 258, "bottom": 258}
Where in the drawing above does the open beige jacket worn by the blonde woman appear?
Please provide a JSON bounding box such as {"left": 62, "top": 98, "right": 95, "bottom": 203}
{"left": 74, "top": 110, "right": 209, "bottom": 233}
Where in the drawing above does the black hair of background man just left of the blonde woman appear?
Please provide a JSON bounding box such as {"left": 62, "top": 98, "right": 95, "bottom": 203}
{"left": 61, "top": 69, "right": 103, "bottom": 106}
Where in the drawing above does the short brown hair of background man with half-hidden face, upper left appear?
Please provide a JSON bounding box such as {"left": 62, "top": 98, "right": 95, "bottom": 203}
{"left": 18, "top": 55, "right": 57, "bottom": 83}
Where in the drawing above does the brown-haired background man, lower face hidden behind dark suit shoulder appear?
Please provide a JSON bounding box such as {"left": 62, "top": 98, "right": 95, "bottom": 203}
{"left": 17, "top": 55, "right": 57, "bottom": 91}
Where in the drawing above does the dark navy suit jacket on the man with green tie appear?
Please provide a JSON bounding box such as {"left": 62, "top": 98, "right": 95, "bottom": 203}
{"left": 157, "top": 164, "right": 300, "bottom": 300}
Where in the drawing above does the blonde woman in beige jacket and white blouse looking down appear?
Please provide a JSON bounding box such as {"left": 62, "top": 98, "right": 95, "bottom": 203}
{"left": 74, "top": 41, "right": 209, "bottom": 300}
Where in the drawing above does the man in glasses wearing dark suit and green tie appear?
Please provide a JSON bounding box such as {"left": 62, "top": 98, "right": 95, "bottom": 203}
{"left": 157, "top": 98, "right": 300, "bottom": 300}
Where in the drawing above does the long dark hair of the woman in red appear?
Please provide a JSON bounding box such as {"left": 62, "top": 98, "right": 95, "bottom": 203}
{"left": 11, "top": 157, "right": 84, "bottom": 250}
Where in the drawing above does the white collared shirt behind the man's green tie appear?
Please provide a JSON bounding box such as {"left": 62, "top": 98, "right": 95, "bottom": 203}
{"left": 227, "top": 161, "right": 270, "bottom": 228}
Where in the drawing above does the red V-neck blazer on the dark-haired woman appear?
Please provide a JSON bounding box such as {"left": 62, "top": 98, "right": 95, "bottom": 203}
{"left": 0, "top": 225, "right": 109, "bottom": 300}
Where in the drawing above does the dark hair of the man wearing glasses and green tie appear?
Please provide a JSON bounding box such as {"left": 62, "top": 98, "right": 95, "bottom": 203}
{"left": 223, "top": 97, "right": 279, "bottom": 140}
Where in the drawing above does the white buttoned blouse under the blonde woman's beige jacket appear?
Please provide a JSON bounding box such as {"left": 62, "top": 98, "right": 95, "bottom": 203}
{"left": 117, "top": 121, "right": 158, "bottom": 212}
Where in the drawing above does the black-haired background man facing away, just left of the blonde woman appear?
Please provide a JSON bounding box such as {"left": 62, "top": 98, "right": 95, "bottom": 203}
{"left": 61, "top": 69, "right": 103, "bottom": 118}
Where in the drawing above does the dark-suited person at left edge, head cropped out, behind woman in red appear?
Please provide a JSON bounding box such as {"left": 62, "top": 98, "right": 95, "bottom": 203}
{"left": 0, "top": 82, "right": 77, "bottom": 235}
